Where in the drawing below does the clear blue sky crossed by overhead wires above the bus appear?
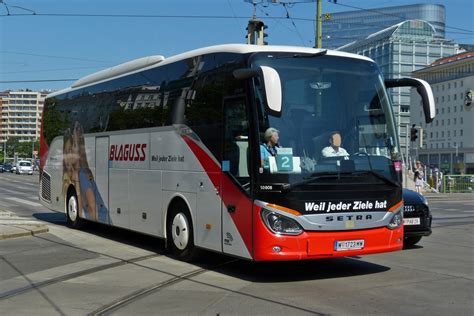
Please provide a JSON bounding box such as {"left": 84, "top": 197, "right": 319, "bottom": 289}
{"left": 0, "top": 0, "right": 474, "bottom": 91}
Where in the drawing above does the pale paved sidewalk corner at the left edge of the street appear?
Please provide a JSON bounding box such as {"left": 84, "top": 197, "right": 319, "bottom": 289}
{"left": 0, "top": 209, "right": 49, "bottom": 240}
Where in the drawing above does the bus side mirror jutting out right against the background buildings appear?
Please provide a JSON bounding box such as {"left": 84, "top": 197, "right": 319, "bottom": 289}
{"left": 385, "top": 78, "right": 436, "bottom": 123}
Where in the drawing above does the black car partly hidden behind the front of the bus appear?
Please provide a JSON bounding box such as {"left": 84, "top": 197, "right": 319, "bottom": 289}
{"left": 403, "top": 189, "right": 432, "bottom": 247}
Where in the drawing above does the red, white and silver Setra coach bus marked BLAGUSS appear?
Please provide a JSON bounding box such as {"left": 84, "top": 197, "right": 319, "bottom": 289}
{"left": 39, "top": 44, "right": 434, "bottom": 261}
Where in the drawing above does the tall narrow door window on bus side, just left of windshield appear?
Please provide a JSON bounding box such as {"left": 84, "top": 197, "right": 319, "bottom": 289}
{"left": 223, "top": 96, "right": 249, "bottom": 184}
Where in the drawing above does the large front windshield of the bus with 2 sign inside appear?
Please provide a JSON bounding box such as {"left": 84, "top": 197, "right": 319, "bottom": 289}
{"left": 251, "top": 53, "right": 401, "bottom": 184}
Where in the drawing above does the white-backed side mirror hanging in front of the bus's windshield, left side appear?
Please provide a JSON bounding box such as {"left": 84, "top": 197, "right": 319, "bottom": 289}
{"left": 233, "top": 66, "right": 282, "bottom": 116}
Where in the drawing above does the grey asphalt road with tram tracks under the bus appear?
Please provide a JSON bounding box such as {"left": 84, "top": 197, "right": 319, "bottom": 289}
{"left": 0, "top": 174, "right": 474, "bottom": 315}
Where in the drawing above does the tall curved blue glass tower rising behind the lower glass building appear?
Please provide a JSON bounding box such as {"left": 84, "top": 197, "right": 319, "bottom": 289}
{"left": 323, "top": 4, "right": 446, "bottom": 48}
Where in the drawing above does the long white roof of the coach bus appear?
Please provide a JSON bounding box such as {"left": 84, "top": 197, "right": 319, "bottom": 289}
{"left": 47, "top": 44, "right": 373, "bottom": 98}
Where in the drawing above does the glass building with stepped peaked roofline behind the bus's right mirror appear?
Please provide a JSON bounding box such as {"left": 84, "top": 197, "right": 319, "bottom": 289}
{"left": 339, "top": 20, "right": 459, "bottom": 153}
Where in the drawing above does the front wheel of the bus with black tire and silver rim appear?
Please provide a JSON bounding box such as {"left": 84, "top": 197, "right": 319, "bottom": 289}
{"left": 166, "top": 202, "right": 198, "bottom": 262}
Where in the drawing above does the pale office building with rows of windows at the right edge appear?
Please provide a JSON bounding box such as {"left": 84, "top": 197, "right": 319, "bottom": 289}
{"left": 411, "top": 51, "right": 474, "bottom": 174}
